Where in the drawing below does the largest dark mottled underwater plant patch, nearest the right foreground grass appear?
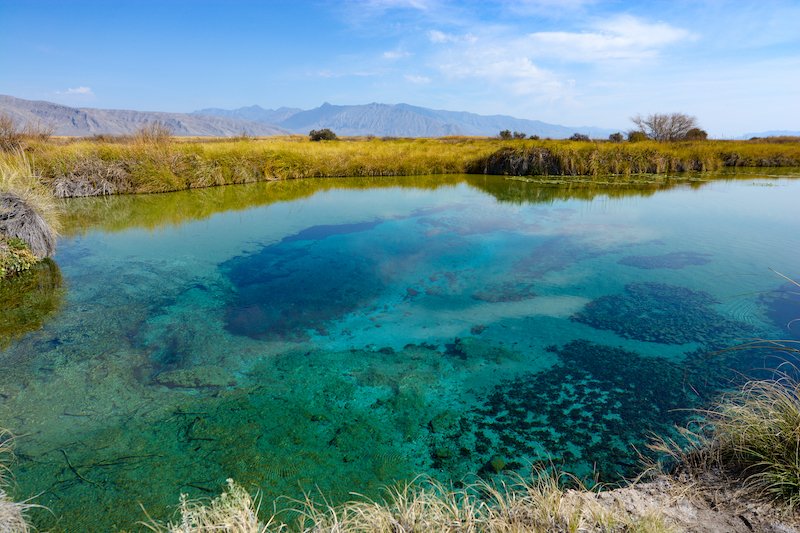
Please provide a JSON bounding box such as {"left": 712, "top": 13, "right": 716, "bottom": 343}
{"left": 432, "top": 339, "right": 697, "bottom": 481}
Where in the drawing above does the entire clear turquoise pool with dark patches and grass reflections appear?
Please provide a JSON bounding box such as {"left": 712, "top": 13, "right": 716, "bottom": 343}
{"left": 0, "top": 170, "right": 800, "bottom": 531}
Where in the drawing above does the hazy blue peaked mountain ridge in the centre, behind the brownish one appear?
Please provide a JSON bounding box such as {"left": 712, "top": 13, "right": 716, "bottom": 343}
{"left": 195, "top": 103, "right": 614, "bottom": 139}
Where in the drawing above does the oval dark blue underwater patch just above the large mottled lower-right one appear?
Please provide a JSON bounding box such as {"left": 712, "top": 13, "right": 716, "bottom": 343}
{"left": 571, "top": 282, "right": 752, "bottom": 347}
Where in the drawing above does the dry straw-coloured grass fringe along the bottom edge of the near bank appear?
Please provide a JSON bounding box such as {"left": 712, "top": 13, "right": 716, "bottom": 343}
{"left": 145, "top": 471, "right": 672, "bottom": 533}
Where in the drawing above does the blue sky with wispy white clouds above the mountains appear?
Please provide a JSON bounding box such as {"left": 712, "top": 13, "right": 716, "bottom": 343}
{"left": 0, "top": 0, "right": 800, "bottom": 137}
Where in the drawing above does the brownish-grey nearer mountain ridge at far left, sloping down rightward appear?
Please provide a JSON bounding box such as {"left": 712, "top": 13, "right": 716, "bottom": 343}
{"left": 0, "top": 95, "right": 289, "bottom": 137}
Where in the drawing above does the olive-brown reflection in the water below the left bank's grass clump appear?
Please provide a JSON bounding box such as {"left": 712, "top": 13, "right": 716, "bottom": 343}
{"left": 0, "top": 259, "right": 64, "bottom": 349}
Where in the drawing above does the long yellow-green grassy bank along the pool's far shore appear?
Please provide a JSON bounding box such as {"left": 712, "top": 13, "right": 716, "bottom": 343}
{"left": 7, "top": 137, "right": 800, "bottom": 197}
